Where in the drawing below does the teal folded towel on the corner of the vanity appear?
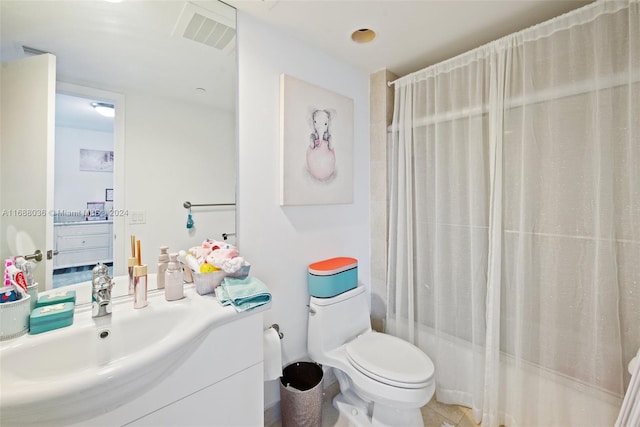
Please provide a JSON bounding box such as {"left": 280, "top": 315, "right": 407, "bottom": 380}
{"left": 216, "top": 276, "right": 271, "bottom": 311}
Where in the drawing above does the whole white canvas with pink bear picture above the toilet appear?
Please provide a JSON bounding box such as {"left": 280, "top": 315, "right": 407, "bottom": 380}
{"left": 280, "top": 74, "right": 353, "bottom": 205}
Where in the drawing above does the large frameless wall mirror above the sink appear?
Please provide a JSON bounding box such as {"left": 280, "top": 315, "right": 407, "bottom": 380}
{"left": 0, "top": 0, "right": 237, "bottom": 296}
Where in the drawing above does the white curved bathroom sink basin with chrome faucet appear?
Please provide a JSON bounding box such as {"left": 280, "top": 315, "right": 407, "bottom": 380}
{"left": 0, "top": 280, "right": 235, "bottom": 425}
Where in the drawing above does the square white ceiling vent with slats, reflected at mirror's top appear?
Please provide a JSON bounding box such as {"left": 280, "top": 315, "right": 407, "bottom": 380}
{"left": 173, "top": 2, "right": 236, "bottom": 53}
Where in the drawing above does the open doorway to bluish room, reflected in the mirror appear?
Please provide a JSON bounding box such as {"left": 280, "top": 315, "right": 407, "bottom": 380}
{"left": 52, "top": 92, "right": 116, "bottom": 288}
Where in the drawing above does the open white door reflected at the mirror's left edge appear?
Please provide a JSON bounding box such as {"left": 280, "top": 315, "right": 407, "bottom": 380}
{"left": 0, "top": 54, "right": 56, "bottom": 290}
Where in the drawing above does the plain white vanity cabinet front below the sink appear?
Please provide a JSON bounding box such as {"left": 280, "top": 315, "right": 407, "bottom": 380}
{"left": 73, "top": 308, "right": 264, "bottom": 427}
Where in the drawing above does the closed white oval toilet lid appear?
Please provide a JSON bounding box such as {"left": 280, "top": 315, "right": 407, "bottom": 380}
{"left": 346, "top": 332, "right": 434, "bottom": 388}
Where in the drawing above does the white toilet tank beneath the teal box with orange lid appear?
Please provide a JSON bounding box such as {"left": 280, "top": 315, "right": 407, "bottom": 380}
{"left": 307, "top": 285, "right": 371, "bottom": 363}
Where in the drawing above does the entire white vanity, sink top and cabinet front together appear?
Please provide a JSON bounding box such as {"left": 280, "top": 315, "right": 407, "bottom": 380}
{"left": 0, "top": 276, "right": 271, "bottom": 426}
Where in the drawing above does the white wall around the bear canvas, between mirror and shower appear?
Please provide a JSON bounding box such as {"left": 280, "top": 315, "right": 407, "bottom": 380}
{"left": 238, "top": 11, "right": 371, "bottom": 407}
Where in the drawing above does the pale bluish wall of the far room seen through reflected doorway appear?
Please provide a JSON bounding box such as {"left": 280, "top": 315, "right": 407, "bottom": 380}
{"left": 54, "top": 126, "right": 113, "bottom": 214}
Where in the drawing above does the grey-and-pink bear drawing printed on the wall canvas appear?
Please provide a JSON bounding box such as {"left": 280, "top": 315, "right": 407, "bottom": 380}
{"left": 307, "top": 110, "right": 336, "bottom": 181}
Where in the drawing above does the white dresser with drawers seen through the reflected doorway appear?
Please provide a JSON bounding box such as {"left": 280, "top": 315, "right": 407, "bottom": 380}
{"left": 53, "top": 221, "right": 113, "bottom": 269}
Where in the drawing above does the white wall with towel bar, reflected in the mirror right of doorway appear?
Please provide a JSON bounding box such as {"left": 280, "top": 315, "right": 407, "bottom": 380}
{"left": 120, "top": 94, "right": 235, "bottom": 274}
